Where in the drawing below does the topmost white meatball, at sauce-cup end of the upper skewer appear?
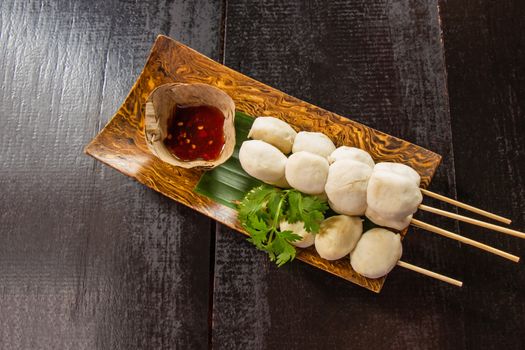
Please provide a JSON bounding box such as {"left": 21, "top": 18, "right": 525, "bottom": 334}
{"left": 248, "top": 117, "right": 297, "bottom": 154}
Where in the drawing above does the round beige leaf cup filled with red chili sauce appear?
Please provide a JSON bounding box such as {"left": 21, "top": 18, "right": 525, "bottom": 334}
{"left": 145, "top": 83, "right": 235, "bottom": 169}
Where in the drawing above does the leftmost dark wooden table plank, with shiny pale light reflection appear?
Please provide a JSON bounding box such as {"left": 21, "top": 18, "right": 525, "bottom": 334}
{"left": 0, "top": 0, "right": 222, "bottom": 349}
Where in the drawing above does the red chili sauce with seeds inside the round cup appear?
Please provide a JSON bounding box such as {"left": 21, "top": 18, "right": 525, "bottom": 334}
{"left": 164, "top": 106, "right": 225, "bottom": 160}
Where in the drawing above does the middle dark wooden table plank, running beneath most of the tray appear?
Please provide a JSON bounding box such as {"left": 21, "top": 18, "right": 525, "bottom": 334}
{"left": 213, "top": 1, "right": 464, "bottom": 349}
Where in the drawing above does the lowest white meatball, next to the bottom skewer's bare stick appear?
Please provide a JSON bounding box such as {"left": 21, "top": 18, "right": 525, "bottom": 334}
{"left": 350, "top": 228, "right": 403, "bottom": 278}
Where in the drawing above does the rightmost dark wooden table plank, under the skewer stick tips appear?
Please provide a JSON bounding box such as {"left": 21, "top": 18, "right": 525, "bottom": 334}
{"left": 441, "top": 0, "right": 525, "bottom": 349}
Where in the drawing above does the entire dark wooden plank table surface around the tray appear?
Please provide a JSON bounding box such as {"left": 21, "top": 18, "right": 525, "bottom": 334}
{"left": 0, "top": 0, "right": 525, "bottom": 349}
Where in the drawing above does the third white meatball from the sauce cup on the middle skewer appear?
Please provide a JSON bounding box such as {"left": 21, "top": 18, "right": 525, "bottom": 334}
{"left": 325, "top": 159, "right": 372, "bottom": 216}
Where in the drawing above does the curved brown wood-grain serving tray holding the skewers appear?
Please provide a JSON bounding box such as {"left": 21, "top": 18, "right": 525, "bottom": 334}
{"left": 85, "top": 36, "right": 441, "bottom": 292}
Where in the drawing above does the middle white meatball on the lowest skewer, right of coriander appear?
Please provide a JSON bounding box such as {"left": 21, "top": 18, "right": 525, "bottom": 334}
{"left": 315, "top": 215, "right": 363, "bottom": 260}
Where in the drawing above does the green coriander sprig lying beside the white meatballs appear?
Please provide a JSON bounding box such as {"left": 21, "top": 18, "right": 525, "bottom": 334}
{"left": 238, "top": 185, "right": 328, "bottom": 266}
